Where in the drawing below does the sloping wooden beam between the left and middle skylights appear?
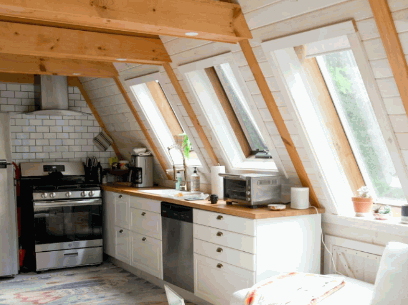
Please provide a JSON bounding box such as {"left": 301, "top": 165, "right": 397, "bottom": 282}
{"left": 163, "top": 63, "right": 220, "bottom": 165}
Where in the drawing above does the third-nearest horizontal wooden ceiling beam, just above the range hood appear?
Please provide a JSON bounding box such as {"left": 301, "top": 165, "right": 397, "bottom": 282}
{"left": 0, "top": 51, "right": 118, "bottom": 78}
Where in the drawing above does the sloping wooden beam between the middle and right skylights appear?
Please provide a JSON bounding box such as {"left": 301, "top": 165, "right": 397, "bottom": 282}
{"left": 239, "top": 40, "right": 321, "bottom": 208}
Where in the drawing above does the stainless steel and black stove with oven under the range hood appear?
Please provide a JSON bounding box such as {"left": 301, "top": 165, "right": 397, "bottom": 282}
{"left": 20, "top": 162, "right": 103, "bottom": 271}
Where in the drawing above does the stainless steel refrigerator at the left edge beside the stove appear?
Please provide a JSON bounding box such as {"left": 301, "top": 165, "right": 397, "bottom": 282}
{"left": 0, "top": 113, "right": 18, "bottom": 277}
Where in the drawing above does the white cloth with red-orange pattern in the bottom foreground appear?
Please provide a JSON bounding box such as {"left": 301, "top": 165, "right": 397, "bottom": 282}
{"left": 245, "top": 272, "right": 346, "bottom": 305}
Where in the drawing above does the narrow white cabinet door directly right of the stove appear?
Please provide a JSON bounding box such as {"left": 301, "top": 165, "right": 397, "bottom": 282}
{"left": 103, "top": 191, "right": 116, "bottom": 257}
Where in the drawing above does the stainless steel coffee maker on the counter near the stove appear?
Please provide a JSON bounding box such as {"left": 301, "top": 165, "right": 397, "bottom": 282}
{"left": 129, "top": 154, "right": 153, "bottom": 187}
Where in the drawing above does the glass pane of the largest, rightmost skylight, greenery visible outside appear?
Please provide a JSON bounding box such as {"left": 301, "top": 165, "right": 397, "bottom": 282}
{"left": 316, "top": 50, "right": 406, "bottom": 204}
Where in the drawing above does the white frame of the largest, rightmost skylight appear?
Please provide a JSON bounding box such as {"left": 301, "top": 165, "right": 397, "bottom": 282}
{"left": 261, "top": 21, "right": 408, "bottom": 214}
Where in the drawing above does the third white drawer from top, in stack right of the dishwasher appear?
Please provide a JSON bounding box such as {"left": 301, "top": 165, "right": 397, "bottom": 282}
{"left": 194, "top": 239, "right": 256, "bottom": 271}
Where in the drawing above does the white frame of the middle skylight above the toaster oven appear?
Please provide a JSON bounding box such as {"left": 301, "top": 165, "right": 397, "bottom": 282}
{"left": 178, "top": 53, "right": 288, "bottom": 177}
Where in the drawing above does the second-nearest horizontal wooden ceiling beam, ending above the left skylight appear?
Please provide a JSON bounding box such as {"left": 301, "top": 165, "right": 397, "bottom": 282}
{"left": 0, "top": 21, "right": 171, "bottom": 65}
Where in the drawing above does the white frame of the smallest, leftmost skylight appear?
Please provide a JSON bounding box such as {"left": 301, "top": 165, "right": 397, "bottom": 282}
{"left": 125, "top": 72, "right": 210, "bottom": 173}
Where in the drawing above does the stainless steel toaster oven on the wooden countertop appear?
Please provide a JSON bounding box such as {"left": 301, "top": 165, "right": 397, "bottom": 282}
{"left": 219, "top": 174, "right": 282, "bottom": 207}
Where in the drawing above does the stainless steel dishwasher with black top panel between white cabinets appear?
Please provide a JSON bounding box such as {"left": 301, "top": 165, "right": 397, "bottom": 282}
{"left": 161, "top": 202, "right": 194, "bottom": 292}
